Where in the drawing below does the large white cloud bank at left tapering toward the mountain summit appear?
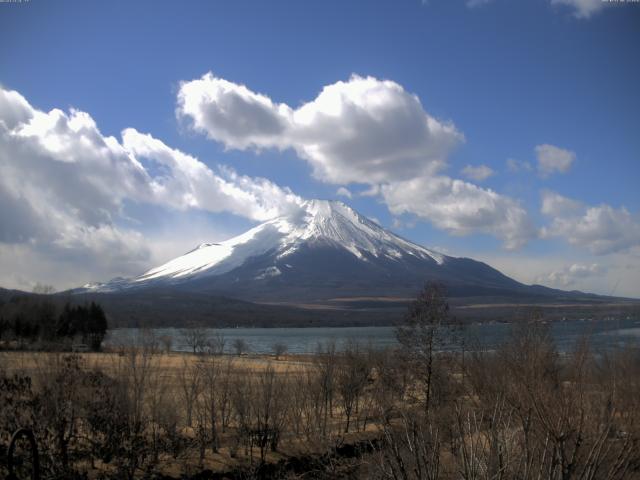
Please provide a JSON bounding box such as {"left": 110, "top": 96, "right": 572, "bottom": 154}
{"left": 0, "top": 88, "right": 301, "bottom": 288}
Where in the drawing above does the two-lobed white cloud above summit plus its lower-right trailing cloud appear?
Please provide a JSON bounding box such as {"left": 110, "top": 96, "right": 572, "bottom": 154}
{"left": 177, "top": 73, "right": 536, "bottom": 248}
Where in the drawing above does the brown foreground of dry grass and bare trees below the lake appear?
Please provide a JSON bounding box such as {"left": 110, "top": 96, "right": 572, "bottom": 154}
{"left": 0, "top": 323, "right": 640, "bottom": 480}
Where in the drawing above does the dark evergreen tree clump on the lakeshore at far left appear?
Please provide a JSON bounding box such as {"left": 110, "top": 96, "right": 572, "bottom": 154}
{"left": 0, "top": 295, "right": 108, "bottom": 350}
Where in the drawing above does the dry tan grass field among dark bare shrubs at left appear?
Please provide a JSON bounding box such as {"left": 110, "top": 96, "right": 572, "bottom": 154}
{"left": 0, "top": 348, "right": 384, "bottom": 478}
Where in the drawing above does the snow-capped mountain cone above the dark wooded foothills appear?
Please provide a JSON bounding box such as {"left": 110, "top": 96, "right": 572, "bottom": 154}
{"left": 82, "top": 200, "right": 588, "bottom": 305}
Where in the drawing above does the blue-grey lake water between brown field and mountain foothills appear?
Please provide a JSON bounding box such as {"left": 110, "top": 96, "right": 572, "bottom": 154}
{"left": 105, "top": 318, "right": 640, "bottom": 353}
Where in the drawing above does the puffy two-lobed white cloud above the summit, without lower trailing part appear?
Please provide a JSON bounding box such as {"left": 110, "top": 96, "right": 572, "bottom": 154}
{"left": 177, "top": 73, "right": 464, "bottom": 184}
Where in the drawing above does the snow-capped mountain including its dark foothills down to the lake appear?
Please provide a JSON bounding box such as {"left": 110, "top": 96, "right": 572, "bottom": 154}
{"left": 70, "top": 200, "right": 637, "bottom": 327}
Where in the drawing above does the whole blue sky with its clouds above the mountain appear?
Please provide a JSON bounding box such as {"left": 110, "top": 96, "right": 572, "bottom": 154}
{"left": 0, "top": 0, "right": 640, "bottom": 296}
